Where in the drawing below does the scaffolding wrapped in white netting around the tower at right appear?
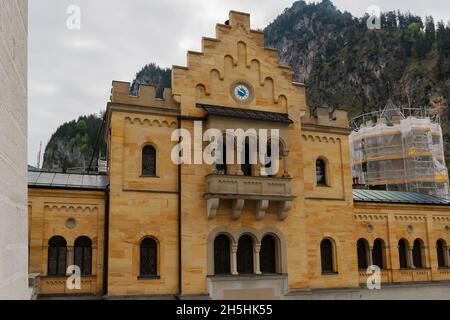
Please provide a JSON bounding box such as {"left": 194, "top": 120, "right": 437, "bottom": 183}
{"left": 350, "top": 100, "right": 449, "bottom": 199}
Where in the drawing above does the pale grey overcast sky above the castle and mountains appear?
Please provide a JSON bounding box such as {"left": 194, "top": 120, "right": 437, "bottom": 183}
{"left": 28, "top": 0, "right": 450, "bottom": 165}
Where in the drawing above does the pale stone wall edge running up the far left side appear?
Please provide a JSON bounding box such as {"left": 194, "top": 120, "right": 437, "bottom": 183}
{"left": 0, "top": 0, "right": 31, "bottom": 299}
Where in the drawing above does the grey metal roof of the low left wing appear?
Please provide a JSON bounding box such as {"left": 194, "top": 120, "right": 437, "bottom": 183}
{"left": 28, "top": 171, "right": 109, "bottom": 190}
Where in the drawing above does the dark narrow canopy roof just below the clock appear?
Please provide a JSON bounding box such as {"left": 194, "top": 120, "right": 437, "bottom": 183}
{"left": 197, "top": 104, "right": 293, "bottom": 124}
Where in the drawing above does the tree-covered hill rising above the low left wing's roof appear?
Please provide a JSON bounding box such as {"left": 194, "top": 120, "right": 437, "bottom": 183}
{"left": 42, "top": 114, "right": 106, "bottom": 172}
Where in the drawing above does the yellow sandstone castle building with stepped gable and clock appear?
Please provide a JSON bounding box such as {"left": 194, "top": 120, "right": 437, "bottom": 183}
{"left": 25, "top": 11, "right": 450, "bottom": 299}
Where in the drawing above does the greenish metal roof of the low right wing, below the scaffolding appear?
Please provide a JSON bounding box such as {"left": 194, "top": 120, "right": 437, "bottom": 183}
{"left": 353, "top": 189, "right": 450, "bottom": 205}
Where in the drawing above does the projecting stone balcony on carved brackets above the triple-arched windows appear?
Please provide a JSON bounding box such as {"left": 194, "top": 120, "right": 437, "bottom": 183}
{"left": 205, "top": 174, "right": 295, "bottom": 220}
